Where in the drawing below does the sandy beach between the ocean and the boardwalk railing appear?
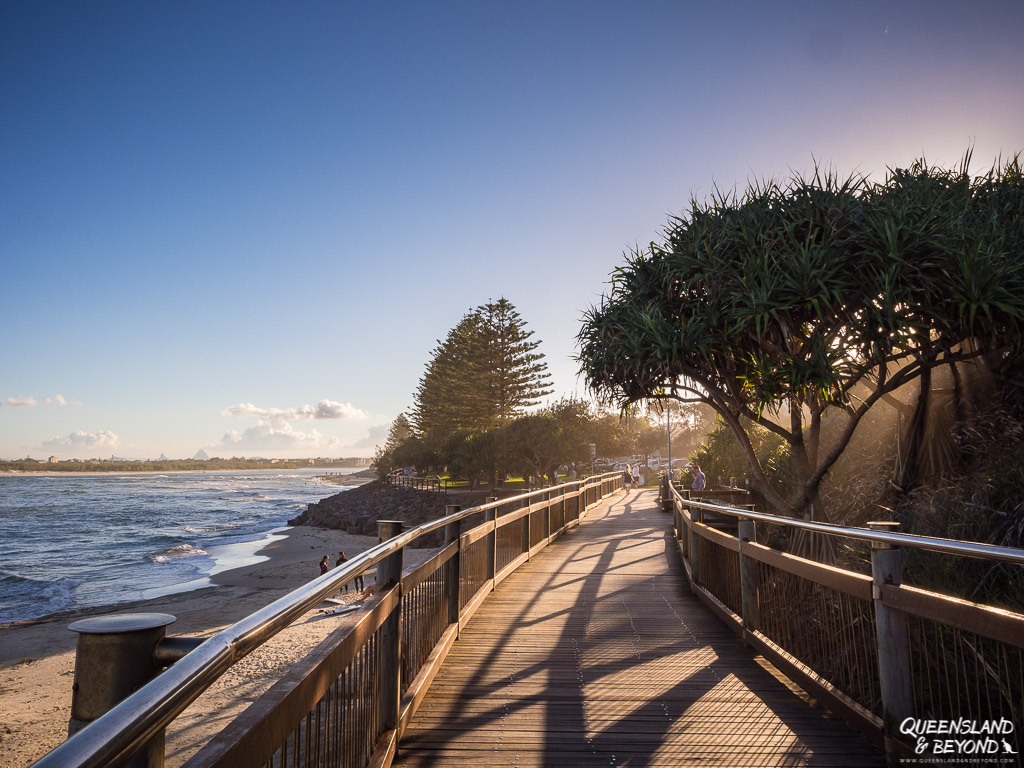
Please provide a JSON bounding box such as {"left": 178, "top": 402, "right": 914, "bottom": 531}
{"left": 0, "top": 526, "right": 429, "bottom": 768}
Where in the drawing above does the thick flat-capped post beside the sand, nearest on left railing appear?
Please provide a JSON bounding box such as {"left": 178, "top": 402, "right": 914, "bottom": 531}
{"left": 68, "top": 613, "right": 177, "bottom": 768}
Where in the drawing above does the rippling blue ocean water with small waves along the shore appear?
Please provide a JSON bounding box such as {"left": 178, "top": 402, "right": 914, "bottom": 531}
{"left": 0, "top": 469, "right": 356, "bottom": 623}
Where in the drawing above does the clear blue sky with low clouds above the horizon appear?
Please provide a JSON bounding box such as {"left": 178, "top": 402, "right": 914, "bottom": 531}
{"left": 0, "top": 0, "right": 1024, "bottom": 458}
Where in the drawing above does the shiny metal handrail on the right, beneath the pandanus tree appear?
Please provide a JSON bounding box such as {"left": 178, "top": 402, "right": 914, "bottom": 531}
{"left": 672, "top": 486, "right": 1024, "bottom": 565}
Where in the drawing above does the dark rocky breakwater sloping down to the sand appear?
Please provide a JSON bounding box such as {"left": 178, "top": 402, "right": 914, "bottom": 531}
{"left": 288, "top": 482, "right": 485, "bottom": 547}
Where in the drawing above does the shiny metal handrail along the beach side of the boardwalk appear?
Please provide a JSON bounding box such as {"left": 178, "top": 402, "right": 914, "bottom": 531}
{"left": 33, "top": 472, "right": 621, "bottom": 768}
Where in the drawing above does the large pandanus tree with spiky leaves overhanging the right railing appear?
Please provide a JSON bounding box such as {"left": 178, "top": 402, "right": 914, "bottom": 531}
{"left": 578, "top": 155, "right": 1024, "bottom": 552}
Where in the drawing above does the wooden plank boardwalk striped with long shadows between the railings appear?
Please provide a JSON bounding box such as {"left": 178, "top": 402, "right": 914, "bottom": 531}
{"left": 394, "top": 490, "right": 885, "bottom": 768}
